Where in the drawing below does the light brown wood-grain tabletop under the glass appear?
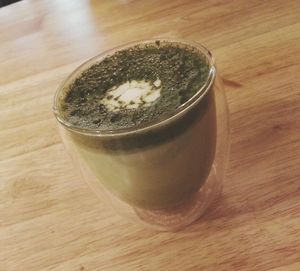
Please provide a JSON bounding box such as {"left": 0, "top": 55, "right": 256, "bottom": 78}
{"left": 0, "top": 0, "right": 300, "bottom": 271}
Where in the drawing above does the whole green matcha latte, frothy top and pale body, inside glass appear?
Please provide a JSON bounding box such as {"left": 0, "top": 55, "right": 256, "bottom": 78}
{"left": 57, "top": 40, "right": 216, "bottom": 210}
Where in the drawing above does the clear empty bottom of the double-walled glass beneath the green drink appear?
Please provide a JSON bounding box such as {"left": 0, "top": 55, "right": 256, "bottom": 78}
{"left": 81, "top": 160, "right": 222, "bottom": 231}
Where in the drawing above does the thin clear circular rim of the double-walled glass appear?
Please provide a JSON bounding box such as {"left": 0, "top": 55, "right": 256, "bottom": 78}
{"left": 52, "top": 38, "right": 216, "bottom": 137}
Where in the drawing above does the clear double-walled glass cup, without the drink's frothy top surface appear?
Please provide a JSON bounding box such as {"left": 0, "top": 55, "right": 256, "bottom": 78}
{"left": 53, "top": 39, "right": 229, "bottom": 231}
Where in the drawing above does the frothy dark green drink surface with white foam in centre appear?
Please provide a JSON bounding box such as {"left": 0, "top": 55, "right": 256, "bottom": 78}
{"left": 61, "top": 41, "right": 209, "bottom": 130}
